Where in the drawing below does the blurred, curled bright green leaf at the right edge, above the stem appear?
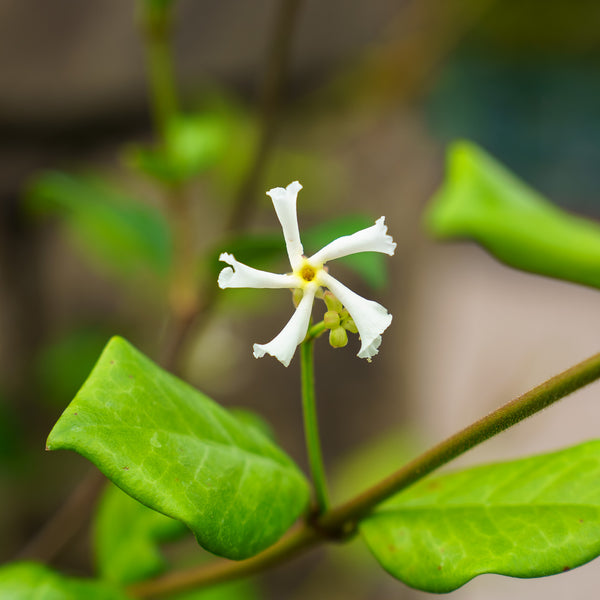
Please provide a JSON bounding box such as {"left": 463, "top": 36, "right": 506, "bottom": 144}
{"left": 426, "top": 141, "right": 600, "bottom": 287}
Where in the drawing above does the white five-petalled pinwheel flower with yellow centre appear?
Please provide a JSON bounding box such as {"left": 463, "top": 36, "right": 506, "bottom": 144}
{"left": 218, "top": 181, "right": 396, "bottom": 367}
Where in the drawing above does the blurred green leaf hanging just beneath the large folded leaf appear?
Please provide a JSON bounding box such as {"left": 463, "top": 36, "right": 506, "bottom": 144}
{"left": 93, "top": 485, "right": 187, "bottom": 584}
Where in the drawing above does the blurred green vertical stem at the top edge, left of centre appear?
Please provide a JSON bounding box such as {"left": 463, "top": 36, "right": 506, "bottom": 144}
{"left": 138, "top": 0, "right": 177, "bottom": 142}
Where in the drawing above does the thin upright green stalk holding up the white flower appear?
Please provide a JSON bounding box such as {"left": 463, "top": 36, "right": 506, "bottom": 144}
{"left": 300, "top": 338, "right": 329, "bottom": 514}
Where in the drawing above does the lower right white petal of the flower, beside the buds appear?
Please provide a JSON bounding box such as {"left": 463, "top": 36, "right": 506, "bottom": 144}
{"left": 319, "top": 271, "right": 392, "bottom": 359}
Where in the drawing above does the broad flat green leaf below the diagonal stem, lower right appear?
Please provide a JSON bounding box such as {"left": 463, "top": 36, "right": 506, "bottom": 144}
{"left": 360, "top": 441, "right": 600, "bottom": 593}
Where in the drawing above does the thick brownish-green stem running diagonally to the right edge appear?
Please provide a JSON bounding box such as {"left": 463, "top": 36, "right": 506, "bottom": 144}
{"left": 128, "top": 350, "right": 600, "bottom": 598}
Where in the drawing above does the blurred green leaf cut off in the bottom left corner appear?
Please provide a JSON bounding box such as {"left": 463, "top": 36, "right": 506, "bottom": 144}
{"left": 0, "top": 562, "right": 127, "bottom": 600}
